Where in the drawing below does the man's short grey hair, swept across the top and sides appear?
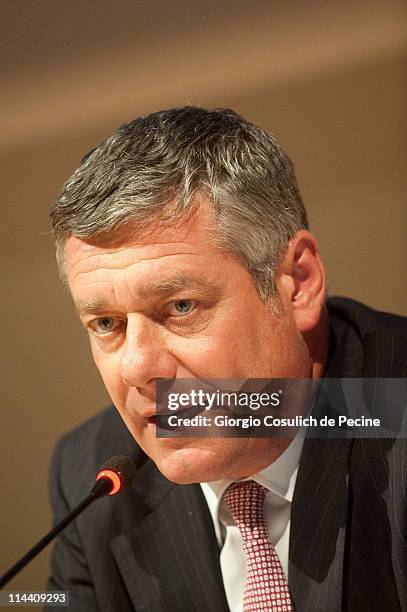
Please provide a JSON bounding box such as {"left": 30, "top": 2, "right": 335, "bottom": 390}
{"left": 51, "top": 107, "right": 308, "bottom": 300}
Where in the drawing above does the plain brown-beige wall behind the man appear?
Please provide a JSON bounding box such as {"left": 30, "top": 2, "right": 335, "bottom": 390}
{"left": 0, "top": 0, "right": 407, "bottom": 589}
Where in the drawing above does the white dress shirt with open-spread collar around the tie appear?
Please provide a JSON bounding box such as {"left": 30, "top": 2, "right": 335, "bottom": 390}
{"left": 201, "top": 432, "right": 304, "bottom": 612}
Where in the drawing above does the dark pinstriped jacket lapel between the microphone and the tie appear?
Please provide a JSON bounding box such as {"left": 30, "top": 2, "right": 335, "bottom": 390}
{"left": 111, "top": 460, "right": 228, "bottom": 612}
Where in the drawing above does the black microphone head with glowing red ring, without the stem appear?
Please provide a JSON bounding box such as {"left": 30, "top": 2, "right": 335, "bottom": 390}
{"left": 93, "top": 455, "right": 136, "bottom": 497}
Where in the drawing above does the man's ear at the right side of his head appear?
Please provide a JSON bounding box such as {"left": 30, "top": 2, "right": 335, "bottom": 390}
{"left": 276, "top": 230, "right": 326, "bottom": 333}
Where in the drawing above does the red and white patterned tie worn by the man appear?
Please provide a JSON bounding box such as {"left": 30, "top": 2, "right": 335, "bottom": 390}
{"left": 223, "top": 480, "right": 294, "bottom": 612}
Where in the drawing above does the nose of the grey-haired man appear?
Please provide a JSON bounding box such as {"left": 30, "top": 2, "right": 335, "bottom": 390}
{"left": 120, "top": 313, "right": 177, "bottom": 399}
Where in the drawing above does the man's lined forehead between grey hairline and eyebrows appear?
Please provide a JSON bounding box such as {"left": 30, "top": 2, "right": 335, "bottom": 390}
{"left": 64, "top": 200, "right": 253, "bottom": 302}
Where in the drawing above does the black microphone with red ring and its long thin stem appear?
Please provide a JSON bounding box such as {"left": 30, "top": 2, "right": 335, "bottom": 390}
{"left": 0, "top": 455, "right": 136, "bottom": 589}
